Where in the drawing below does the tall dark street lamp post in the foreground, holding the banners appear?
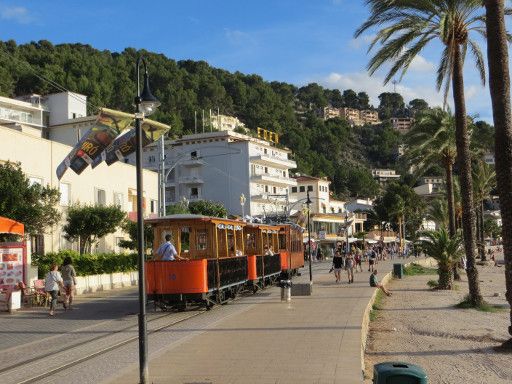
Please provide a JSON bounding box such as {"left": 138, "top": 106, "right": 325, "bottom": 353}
{"left": 135, "top": 57, "right": 160, "bottom": 384}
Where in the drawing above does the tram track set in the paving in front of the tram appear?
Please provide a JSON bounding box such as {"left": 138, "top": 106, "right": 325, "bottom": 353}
{"left": 0, "top": 311, "right": 205, "bottom": 384}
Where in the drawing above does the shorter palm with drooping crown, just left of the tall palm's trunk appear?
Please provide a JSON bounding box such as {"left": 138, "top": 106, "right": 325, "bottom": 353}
{"left": 405, "top": 108, "right": 457, "bottom": 236}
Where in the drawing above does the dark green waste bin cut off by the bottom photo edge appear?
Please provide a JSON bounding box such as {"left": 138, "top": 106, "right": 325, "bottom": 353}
{"left": 373, "top": 362, "right": 428, "bottom": 384}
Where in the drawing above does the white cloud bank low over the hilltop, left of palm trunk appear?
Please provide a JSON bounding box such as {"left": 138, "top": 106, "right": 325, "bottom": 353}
{"left": 318, "top": 72, "right": 443, "bottom": 106}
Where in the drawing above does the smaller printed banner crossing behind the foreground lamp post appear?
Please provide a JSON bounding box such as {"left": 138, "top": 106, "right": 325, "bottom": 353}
{"left": 92, "top": 119, "right": 170, "bottom": 168}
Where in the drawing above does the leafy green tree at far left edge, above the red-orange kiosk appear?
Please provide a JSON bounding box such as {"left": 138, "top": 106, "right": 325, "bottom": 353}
{"left": 0, "top": 162, "right": 61, "bottom": 235}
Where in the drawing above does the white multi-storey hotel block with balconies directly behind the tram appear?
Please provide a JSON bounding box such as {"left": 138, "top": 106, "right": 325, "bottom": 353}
{"left": 142, "top": 130, "right": 297, "bottom": 216}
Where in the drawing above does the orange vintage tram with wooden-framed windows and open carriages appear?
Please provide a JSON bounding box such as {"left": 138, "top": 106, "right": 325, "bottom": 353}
{"left": 145, "top": 215, "right": 304, "bottom": 309}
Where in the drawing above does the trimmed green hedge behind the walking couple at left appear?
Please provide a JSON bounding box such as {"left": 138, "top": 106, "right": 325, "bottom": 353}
{"left": 32, "top": 251, "right": 137, "bottom": 279}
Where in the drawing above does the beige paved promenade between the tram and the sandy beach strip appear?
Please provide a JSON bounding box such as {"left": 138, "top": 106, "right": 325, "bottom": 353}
{"left": 106, "top": 258, "right": 404, "bottom": 384}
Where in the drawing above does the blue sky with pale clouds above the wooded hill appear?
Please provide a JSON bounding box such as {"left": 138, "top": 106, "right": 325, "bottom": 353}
{"left": 0, "top": 0, "right": 498, "bottom": 122}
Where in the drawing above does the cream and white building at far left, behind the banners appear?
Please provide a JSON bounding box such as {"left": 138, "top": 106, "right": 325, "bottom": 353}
{"left": 0, "top": 93, "right": 158, "bottom": 254}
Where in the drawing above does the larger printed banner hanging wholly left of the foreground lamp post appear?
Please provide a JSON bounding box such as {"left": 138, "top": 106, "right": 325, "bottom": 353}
{"left": 57, "top": 108, "right": 133, "bottom": 180}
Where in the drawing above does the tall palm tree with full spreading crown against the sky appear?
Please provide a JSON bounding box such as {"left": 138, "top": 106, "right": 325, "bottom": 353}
{"left": 355, "top": 0, "right": 485, "bottom": 306}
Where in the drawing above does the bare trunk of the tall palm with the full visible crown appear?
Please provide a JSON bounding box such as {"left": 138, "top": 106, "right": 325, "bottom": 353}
{"left": 453, "top": 44, "right": 483, "bottom": 306}
